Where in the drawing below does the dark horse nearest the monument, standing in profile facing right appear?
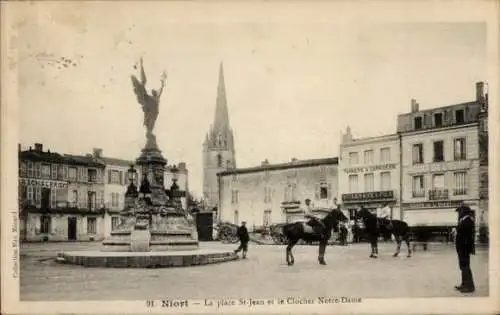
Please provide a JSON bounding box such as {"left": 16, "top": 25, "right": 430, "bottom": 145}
{"left": 283, "top": 209, "right": 347, "bottom": 266}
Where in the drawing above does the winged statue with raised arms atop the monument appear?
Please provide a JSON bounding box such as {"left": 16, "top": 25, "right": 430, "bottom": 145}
{"left": 131, "top": 58, "right": 167, "bottom": 139}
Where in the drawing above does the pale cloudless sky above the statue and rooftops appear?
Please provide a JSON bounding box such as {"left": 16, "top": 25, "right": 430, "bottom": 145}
{"left": 16, "top": 2, "right": 487, "bottom": 196}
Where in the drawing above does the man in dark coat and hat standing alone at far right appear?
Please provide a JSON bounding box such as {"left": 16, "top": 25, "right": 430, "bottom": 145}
{"left": 455, "top": 204, "right": 475, "bottom": 293}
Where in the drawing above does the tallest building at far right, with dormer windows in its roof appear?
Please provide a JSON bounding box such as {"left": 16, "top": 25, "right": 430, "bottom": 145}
{"left": 397, "top": 83, "right": 484, "bottom": 232}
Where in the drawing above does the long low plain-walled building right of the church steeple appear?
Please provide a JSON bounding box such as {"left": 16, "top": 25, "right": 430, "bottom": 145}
{"left": 218, "top": 158, "right": 338, "bottom": 230}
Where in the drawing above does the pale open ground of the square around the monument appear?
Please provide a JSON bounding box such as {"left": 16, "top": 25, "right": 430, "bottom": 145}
{"left": 20, "top": 242, "right": 488, "bottom": 301}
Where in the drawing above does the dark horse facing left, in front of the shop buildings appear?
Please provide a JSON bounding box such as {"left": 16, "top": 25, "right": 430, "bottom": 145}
{"left": 356, "top": 207, "right": 411, "bottom": 258}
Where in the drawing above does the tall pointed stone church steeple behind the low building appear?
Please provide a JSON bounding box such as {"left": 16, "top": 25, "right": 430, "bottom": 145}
{"left": 203, "top": 63, "right": 236, "bottom": 209}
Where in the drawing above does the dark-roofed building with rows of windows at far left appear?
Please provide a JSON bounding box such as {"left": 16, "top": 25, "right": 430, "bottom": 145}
{"left": 19, "top": 143, "right": 104, "bottom": 241}
